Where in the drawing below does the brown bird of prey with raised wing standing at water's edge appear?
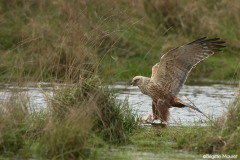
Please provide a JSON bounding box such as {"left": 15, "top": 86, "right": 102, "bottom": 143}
{"left": 131, "top": 37, "right": 225, "bottom": 123}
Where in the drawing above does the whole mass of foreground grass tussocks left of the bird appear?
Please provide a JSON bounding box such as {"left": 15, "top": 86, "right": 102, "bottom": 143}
{"left": 0, "top": 78, "right": 137, "bottom": 159}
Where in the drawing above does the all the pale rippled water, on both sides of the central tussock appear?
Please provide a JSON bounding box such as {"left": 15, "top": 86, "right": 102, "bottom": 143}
{"left": 0, "top": 83, "right": 237, "bottom": 125}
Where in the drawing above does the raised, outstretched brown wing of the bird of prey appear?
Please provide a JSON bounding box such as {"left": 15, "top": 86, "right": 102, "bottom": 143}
{"left": 151, "top": 37, "right": 225, "bottom": 95}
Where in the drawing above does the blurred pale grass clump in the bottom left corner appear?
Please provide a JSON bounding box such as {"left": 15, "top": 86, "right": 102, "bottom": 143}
{"left": 0, "top": 92, "right": 45, "bottom": 156}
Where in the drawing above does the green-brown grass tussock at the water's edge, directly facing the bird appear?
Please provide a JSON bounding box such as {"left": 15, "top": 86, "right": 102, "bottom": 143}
{"left": 52, "top": 77, "right": 137, "bottom": 143}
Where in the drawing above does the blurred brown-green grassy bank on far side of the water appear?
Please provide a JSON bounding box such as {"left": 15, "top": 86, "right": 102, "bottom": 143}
{"left": 0, "top": 0, "right": 240, "bottom": 82}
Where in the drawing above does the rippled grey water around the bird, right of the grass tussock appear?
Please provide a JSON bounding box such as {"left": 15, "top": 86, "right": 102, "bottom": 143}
{"left": 110, "top": 83, "right": 237, "bottom": 125}
